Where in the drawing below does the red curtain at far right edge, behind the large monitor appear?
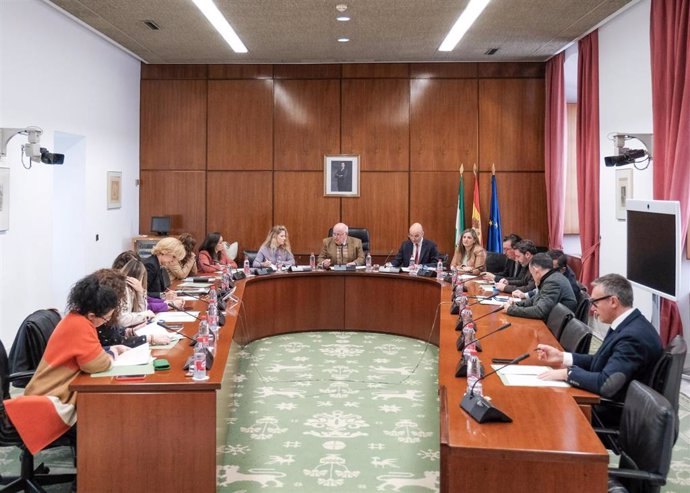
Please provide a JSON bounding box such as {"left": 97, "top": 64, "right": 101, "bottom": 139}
{"left": 649, "top": 0, "right": 690, "bottom": 343}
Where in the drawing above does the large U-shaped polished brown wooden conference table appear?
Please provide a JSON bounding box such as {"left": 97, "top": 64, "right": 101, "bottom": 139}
{"left": 70, "top": 271, "right": 608, "bottom": 493}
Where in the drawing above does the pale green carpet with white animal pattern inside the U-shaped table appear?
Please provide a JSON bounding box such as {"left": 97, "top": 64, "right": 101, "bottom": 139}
{"left": 218, "top": 332, "right": 439, "bottom": 493}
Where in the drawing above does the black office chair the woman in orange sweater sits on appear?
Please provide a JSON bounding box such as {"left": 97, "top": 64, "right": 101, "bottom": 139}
{"left": 0, "top": 341, "right": 77, "bottom": 493}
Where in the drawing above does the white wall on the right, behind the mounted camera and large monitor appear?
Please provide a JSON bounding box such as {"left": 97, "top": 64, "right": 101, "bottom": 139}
{"left": 599, "top": 0, "right": 690, "bottom": 338}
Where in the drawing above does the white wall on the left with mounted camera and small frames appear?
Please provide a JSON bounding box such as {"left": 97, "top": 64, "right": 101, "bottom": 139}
{"left": 0, "top": 0, "right": 140, "bottom": 349}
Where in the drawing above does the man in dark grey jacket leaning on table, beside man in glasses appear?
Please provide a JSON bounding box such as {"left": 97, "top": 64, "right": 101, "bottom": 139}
{"left": 505, "top": 253, "right": 577, "bottom": 320}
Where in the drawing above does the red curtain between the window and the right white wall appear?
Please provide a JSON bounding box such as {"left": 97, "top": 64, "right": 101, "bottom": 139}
{"left": 576, "top": 31, "right": 600, "bottom": 286}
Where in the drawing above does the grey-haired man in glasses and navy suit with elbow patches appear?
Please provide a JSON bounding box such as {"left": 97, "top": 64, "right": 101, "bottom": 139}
{"left": 537, "top": 274, "right": 663, "bottom": 401}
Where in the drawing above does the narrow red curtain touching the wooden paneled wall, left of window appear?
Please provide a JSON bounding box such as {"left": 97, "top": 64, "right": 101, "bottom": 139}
{"left": 544, "top": 52, "right": 566, "bottom": 249}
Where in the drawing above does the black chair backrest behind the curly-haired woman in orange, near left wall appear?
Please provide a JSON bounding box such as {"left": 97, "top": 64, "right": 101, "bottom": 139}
{"left": 9, "top": 310, "right": 60, "bottom": 387}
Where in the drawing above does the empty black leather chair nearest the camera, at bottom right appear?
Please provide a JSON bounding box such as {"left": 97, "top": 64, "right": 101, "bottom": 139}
{"left": 608, "top": 381, "right": 676, "bottom": 493}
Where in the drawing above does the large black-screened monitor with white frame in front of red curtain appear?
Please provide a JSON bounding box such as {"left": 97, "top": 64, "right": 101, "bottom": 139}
{"left": 626, "top": 200, "right": 681, "bottom": 301}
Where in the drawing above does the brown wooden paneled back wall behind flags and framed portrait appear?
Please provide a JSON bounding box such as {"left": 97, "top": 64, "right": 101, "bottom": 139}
{"left": 139, "top": 63, "right": 547, "bottom": 255}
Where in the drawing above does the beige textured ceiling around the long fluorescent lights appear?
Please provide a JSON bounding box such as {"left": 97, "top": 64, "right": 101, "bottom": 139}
{"left": 46, "top": 0, "right": 633, "bottom": 64}
